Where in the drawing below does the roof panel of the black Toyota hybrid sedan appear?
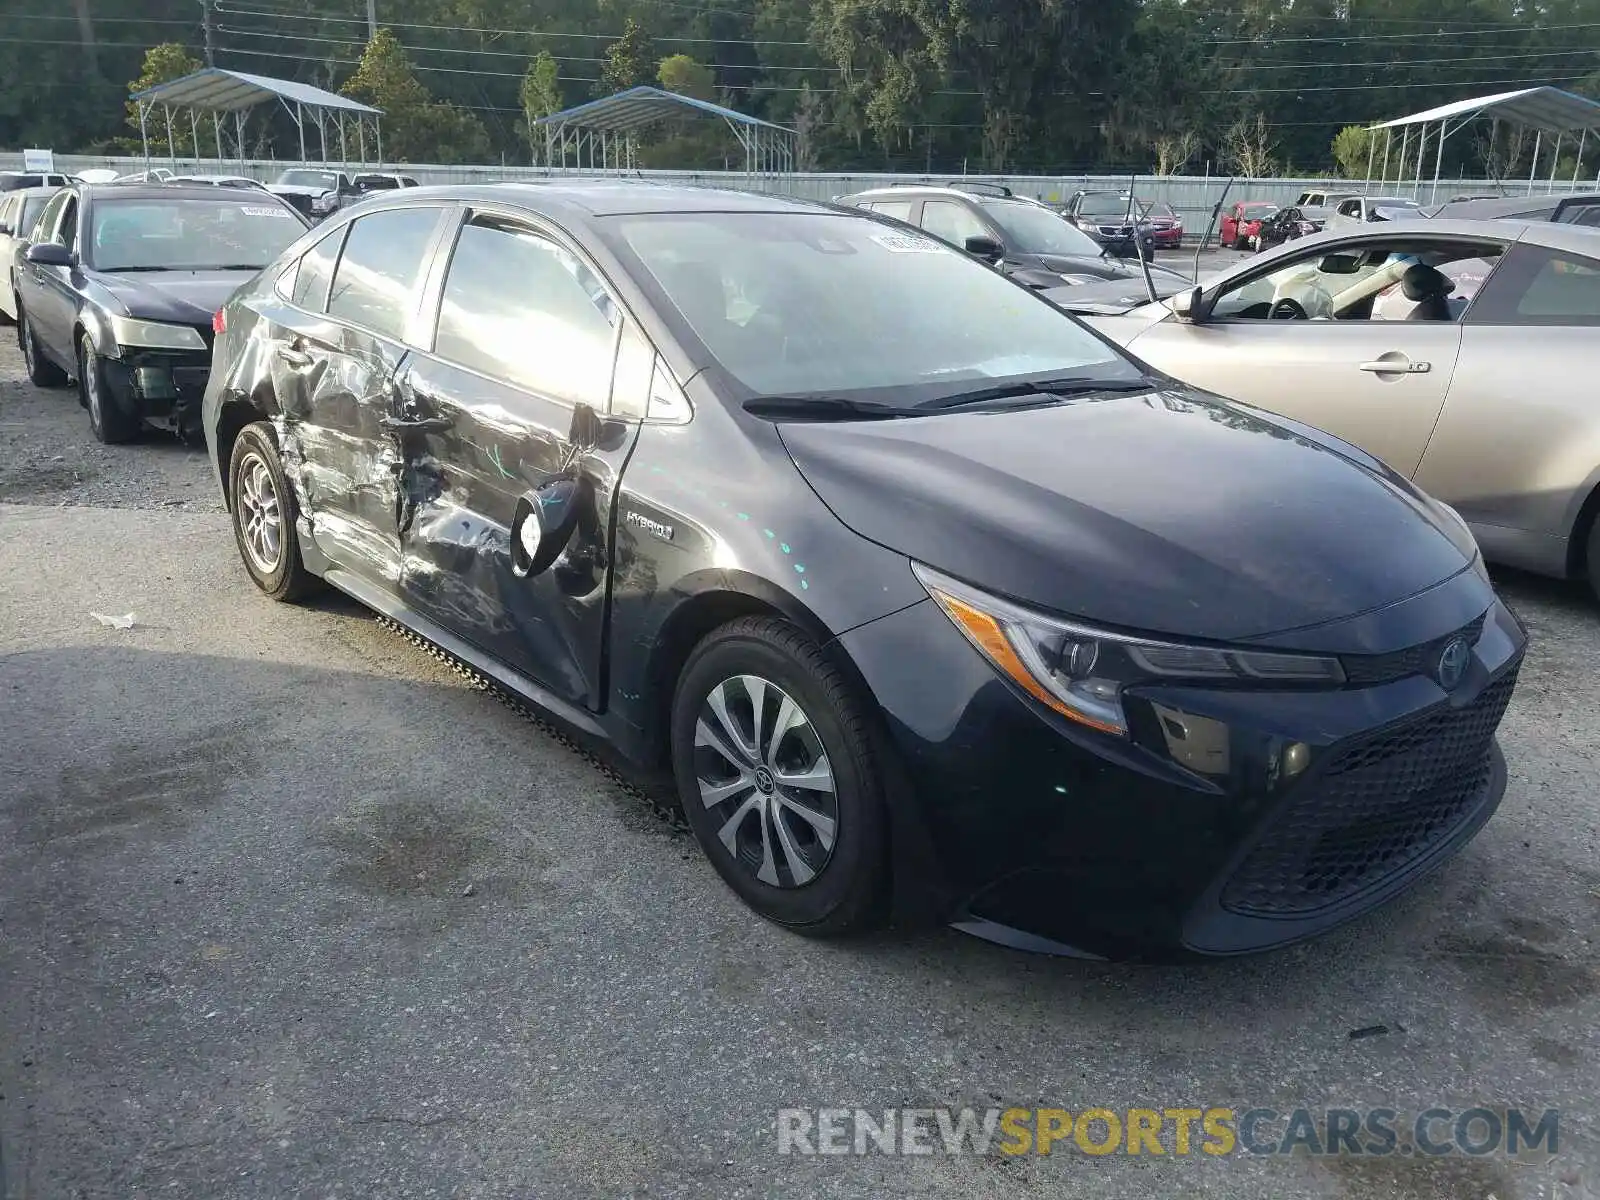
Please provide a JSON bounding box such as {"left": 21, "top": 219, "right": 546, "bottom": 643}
{"left": 366, "top": 179, "right": 838, "bottom": 216}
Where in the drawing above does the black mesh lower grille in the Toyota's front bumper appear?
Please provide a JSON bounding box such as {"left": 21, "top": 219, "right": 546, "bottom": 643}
{"left": 1222, "top": 670, "right": 1517, "bottom": 917}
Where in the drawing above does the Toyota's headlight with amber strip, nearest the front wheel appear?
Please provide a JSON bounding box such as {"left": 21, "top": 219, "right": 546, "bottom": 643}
{"left": 912, "top": 563, "right": 1344, "bottom": 736}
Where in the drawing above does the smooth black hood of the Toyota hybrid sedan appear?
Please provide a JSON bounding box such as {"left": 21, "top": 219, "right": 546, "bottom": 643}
{"left": 781, "top": 389, "right": 1474, "bottom": 642}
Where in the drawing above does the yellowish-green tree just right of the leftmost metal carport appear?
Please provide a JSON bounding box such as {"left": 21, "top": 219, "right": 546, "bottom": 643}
{"left": 339, "top": 29, "right": 490, "bottom": 163}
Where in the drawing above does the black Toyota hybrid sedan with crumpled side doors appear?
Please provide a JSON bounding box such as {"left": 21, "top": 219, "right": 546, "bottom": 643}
{"left": 205, "top": 182, "right": 1525, "bottom": 957}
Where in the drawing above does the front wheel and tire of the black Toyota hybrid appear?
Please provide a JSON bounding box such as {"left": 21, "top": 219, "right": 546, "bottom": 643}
{"left": 670, "top": 618, "right": 888, "bottom": 938}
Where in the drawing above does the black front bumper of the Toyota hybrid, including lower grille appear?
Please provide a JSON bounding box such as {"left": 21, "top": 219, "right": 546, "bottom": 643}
{"left": 840, "top": 589, "right": 1525, "bottom": 958}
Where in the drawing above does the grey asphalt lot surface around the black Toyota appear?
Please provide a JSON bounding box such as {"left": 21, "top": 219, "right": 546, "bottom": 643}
{"left": 0, "top": 330, "right": 1600, "bottom": 1200}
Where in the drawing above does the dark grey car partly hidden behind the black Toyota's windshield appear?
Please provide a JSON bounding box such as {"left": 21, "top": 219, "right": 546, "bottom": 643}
{"left": 837, "top": 184, "right": 1187, "bottom": 288}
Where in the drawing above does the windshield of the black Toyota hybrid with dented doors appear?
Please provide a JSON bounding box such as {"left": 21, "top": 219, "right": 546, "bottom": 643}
{"left": 611, "top": 213, "right": 1139, "bottom": 405}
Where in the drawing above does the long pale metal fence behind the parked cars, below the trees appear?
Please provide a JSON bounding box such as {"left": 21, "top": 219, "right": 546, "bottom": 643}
{"left": 0, "top": 154, "right": 1590, "bottom": 230}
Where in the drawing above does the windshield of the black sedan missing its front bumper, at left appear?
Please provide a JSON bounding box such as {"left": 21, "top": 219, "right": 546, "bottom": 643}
{"left": 86, "top": 198, "right": 306, "bottom": 270}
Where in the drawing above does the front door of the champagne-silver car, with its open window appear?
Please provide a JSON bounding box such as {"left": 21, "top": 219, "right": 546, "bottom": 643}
{"left": 1130, "top": 242, "right": 1499, "bottom": 477}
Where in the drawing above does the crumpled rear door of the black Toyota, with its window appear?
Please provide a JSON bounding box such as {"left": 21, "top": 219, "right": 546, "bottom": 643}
{"left": 270, "top": 208, "right": 445, "bottom": 590}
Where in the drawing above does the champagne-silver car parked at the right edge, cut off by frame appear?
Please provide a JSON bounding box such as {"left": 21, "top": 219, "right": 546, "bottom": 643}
{"left": 1050, "top": 218, "right": 1600, "bottom": 592}
